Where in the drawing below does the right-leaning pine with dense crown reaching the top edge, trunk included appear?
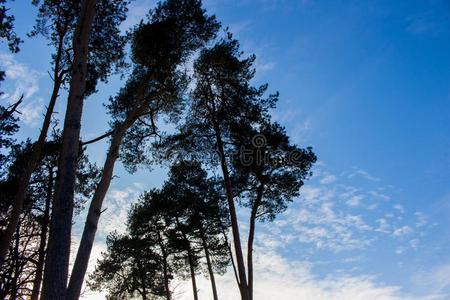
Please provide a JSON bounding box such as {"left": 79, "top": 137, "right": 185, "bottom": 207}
{"left": 68, "top": 0, "right": 219, "bottom": 299}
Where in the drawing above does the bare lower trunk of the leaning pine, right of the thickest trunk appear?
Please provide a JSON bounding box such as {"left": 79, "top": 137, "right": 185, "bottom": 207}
{"left": 67, "top": 120, "right": 131, "bottom": 300}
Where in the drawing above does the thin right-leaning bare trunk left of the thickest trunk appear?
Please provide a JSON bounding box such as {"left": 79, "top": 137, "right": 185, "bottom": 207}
{"left": 0, "top": 44, "right": 64, "bottom": 268}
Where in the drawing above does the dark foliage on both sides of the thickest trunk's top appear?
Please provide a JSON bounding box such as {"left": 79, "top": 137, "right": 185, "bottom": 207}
{"left": 29, "top": 0, "right": 131, "bottom": 95}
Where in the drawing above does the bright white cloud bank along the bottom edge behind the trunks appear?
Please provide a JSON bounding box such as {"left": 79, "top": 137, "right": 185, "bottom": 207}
{"left": 82, "top": 249, "right": 410, "bottom": 300}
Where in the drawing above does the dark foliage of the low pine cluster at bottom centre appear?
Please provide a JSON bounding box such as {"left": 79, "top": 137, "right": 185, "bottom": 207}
{"left": 90, "top": 162, "right": 230, "bottom": 299}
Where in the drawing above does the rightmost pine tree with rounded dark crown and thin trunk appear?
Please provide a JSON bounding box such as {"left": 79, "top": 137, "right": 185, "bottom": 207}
{"left": 232, "top": 121, "right": 316, "bottom": 299}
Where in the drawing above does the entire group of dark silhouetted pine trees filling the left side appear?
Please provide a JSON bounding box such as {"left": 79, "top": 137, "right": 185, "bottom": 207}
{"left": 0, "top": 0, "right": 316, "bottom": 300}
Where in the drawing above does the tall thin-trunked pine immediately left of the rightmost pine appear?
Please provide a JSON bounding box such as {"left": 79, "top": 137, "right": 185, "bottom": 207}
{"left": 161, "top": 34, "right": 277, "bottom": 300}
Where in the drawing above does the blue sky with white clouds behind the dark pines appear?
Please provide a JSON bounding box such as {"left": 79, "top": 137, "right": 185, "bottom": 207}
{"left": 0, "top": 0, "right": 450, "bottom": 300}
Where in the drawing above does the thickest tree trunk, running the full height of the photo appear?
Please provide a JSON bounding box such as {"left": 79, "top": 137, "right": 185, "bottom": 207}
{"left": 43, "top": 0, "right": 96, "bottom": 300}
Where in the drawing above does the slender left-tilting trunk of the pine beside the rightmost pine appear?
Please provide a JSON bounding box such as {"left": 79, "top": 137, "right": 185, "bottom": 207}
{"left": 215, "top": 128, "right": 249, "bottom": 300}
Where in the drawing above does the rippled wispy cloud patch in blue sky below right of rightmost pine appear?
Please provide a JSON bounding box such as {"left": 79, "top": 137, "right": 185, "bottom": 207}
{"left": 264, "top": 166, "right": 425, "bottom": 252}
